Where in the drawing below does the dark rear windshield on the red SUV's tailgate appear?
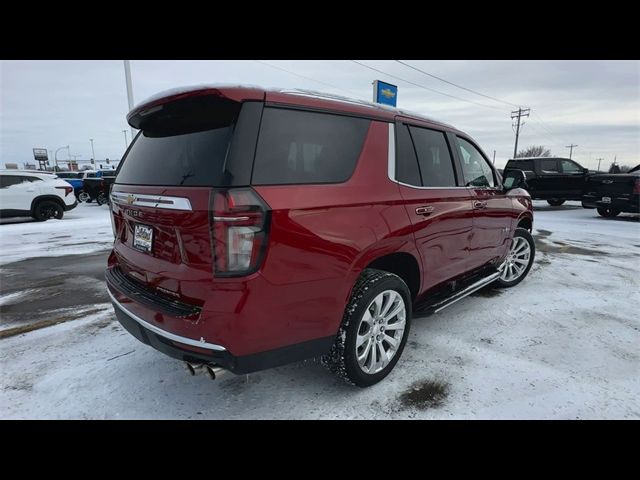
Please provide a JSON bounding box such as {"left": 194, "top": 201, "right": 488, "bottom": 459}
{"left": 113, "top": 97, "right": 241, "bottom": 186}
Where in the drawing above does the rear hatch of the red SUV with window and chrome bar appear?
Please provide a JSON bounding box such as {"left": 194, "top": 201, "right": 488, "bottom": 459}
{"left": 110, "top": 91, "right": 262, "bottom": 307}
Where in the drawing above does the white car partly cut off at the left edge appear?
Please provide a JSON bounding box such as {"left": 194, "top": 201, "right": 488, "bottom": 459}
{"left": 0, "top": 170, "right": 78, "bottom": 221}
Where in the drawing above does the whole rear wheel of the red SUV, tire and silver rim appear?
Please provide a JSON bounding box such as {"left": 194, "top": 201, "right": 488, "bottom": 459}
{"left": 322, "top": 269, "right": 411, "bottom": 387}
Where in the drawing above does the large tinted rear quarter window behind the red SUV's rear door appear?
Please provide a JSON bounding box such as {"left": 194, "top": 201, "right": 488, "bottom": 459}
{"left": 252, "top": 108, "right": 371, "bottom": 185}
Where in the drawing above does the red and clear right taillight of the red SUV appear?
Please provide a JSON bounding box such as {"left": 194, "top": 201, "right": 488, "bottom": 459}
{"left": 210, "top": 188, "right": 269, "bottom": 277}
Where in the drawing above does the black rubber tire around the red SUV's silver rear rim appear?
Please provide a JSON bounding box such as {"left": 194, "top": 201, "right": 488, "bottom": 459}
{"left": 322, "top": 268, "right": 412, "bottom": 387}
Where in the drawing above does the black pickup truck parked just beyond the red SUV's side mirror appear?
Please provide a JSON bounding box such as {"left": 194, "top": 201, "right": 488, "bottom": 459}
{"left": 504, "top": 157, "right": 591, "bottom": 207}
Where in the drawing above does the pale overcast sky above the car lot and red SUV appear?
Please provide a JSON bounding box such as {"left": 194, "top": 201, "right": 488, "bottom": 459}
{"left": 0, "top": 60, "right": 640, "bottom": 168}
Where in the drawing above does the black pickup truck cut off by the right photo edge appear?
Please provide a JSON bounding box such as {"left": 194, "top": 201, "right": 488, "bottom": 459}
{"left": 582, "top": 165, "right": 640, "bottom": 217}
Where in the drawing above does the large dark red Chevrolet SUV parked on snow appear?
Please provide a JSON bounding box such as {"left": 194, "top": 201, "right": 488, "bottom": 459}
{"left": 106, "top": 86, "right": 534, "bottom": 386}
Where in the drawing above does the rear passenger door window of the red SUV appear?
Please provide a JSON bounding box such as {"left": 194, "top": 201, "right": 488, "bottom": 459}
{"left": 409, "top": 126, "right": 456, "bottom": 187}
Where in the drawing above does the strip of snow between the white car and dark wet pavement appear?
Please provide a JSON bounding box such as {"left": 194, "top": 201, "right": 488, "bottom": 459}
{"left": 0, "top": 202, "right": 113, "bottom": 265}
